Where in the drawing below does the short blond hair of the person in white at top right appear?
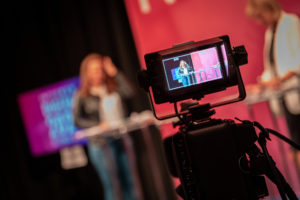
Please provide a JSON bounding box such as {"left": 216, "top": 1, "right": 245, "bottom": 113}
{"left": 245, "top": 0, "right": 281, "bottom": 18}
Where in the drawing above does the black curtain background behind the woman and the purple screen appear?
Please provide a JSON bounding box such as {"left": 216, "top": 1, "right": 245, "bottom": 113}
{"left": 0, "top": 0, "right": 148, "bottom": 200}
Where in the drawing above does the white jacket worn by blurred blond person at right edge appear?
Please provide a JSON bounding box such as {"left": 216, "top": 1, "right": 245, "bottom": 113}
{"left": 261, "top": 12, "right": 300, "bottom": 114}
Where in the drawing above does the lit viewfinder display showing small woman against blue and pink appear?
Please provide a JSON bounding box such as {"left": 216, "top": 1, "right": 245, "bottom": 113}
{"left": 162, "top": 45, "right": 226, "bottom": 91}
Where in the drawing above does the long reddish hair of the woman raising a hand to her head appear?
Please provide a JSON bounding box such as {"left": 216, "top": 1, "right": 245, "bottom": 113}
{"left": 79, "top": 53, "right": 117, "bottom": 96}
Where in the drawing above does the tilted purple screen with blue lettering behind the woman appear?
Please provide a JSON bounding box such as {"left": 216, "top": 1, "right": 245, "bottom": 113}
{"left": 18, "top": 78, "right": 84, "bottom": 156}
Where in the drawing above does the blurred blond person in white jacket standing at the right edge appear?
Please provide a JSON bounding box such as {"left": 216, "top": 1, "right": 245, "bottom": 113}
{"left": 246, "top": 0, "right": 300, "bottom": 178}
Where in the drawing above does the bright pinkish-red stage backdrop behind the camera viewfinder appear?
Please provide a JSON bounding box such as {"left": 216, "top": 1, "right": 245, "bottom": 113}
{"left": 125, "top": 0, "right": 300, "bottom": 196}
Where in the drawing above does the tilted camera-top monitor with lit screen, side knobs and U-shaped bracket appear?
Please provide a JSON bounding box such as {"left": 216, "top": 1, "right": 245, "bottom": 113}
{"left": 137, "top": 36, "right": 248, "bottom": 120}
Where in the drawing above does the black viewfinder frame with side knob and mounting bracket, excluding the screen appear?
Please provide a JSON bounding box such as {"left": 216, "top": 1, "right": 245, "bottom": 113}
{"left": 143, "top": 35, "right": 248, "bottom": 120}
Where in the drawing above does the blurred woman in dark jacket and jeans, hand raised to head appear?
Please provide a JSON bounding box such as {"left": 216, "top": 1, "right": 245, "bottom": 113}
{"left": 73, "top": 53, "right": 134, "bottom": 200}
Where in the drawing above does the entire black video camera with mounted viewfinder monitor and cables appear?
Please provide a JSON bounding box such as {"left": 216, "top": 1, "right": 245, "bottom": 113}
{"left": 138, "top": 36, "right": 299, "bottom": 200}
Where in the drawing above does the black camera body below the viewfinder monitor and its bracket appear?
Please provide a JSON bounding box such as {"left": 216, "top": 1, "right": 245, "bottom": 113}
{"left": 164, "top": 119, "right": 268, "bottom": 200}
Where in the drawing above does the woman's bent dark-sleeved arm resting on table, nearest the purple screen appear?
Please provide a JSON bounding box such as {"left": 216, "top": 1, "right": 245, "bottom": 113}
{"left": 73, "top": 92, "right": 98, "bottom": 128}
